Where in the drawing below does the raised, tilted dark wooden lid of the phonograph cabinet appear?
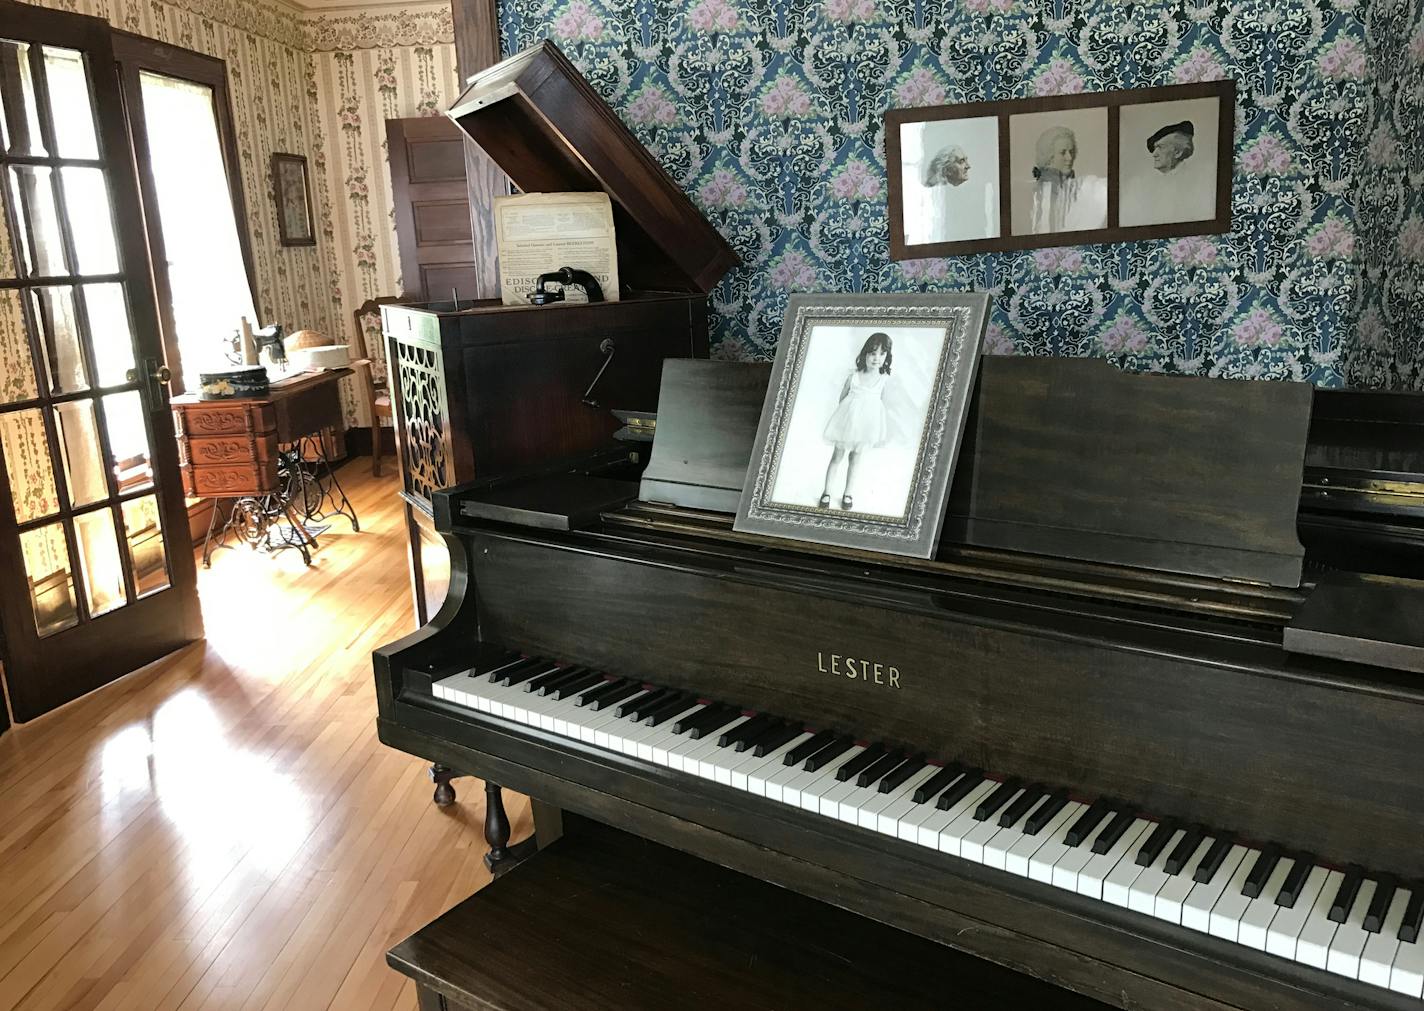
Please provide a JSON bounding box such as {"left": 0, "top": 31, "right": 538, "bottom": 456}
{"left": 447, "top": 40, "right": 740, "bottom": 295}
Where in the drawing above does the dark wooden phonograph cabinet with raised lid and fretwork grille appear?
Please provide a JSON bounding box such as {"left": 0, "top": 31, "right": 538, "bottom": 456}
{"left": 382, "top": 41, "right": 738, "bottom": 624}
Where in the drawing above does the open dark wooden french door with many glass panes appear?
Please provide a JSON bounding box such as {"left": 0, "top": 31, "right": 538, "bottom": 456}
{"left": 0, "top": 0, "right": 202, "bottom": 722}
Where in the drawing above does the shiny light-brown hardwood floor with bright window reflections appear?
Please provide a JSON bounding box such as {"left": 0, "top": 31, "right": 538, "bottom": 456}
{"left": 0, "top": 460, "right": 530, "bottom": 1011}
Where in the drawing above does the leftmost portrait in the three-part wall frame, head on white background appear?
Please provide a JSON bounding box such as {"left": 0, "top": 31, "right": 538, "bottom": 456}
{"left": 900, "top": 117, "right": 1000, "bottom": 245}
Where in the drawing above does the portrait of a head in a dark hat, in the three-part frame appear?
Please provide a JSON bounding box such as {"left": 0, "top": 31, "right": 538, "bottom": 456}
{"left": 1118, "top": 98, "right": 1220, "bottom": 228}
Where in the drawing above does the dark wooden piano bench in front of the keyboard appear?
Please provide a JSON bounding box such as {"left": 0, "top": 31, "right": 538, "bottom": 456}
{"left": 386, "top": 812, "right": 1105, "bottom": 1011}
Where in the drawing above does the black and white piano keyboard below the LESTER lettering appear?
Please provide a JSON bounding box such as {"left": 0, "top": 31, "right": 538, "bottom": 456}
{"left": 433, "top": 658, "right": 1424, "bottom": 997}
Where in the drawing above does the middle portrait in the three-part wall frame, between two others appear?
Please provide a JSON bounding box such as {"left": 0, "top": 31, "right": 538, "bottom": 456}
{"left": 1008, "top": 108, "right": 1108, "bottom": 235}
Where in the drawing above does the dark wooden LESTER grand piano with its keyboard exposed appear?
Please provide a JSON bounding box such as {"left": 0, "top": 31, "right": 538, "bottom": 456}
{"left": 375, "top": 350, "right": 1424, "bottom": 1011}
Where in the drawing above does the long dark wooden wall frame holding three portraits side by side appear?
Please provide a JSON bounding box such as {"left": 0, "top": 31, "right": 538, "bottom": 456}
{"left": 886, "top": 81, "right": 1236, "bottom": 259}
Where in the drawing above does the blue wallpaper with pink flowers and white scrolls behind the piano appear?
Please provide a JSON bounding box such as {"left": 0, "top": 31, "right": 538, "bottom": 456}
{"left": 501, "top": 0, "right": 1424, "bottom": 386}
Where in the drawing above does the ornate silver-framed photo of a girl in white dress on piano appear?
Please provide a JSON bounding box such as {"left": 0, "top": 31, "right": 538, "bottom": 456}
{"left": 733, "top": 292, "right": 990, "bottom": 558}
